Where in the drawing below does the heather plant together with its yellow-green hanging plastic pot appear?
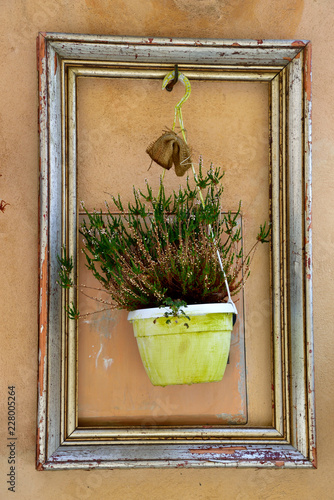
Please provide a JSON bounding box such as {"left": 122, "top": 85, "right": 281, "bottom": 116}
{"left": 59, "top": 161, "right": 269, "bottom": 386}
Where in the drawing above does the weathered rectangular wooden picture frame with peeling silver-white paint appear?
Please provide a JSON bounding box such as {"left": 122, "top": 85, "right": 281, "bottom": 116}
{"left": 37, "top": 33, "right": 316, "bottom": 470}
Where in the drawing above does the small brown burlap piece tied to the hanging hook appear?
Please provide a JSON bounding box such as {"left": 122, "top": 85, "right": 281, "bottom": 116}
{"left": 146, "top": 130, "right": 191, "bottom": 177}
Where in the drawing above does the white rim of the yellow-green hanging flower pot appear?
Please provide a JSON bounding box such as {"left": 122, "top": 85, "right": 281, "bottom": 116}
{"left": 128, "top": 302, "right": 236, "bottom": 321}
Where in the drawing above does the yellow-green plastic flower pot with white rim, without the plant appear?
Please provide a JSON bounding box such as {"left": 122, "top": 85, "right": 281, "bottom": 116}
{"left": 128, "top": 303, "right": 235, "bottom": 386}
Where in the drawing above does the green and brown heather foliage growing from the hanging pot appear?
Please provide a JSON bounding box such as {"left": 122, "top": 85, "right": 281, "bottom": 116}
{"left": 59, "top": 163, "right": 269, "bottom": 317}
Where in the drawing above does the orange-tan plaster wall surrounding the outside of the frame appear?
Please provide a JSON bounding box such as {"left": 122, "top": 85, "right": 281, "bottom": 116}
{"left": 0, "top": 0, "right": 334, "bottom": 500}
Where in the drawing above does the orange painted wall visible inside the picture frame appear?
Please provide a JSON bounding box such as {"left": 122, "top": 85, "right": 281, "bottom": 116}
{"left": 78, "top": 78, "right": 272, "bottom": 426}
